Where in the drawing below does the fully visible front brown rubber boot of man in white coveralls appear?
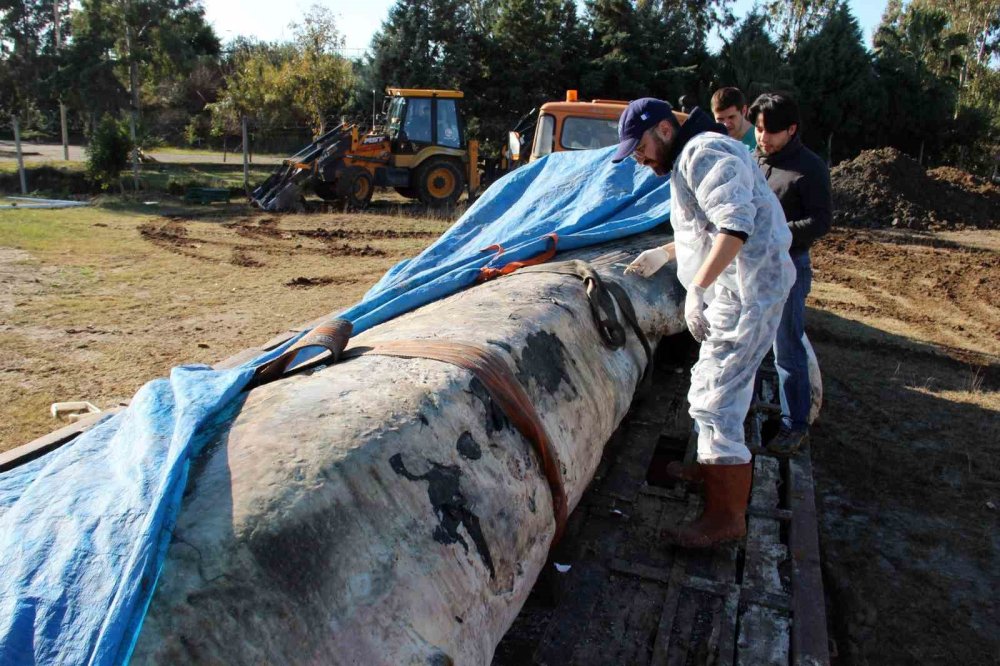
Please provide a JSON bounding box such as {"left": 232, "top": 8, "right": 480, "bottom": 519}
{"left": 666, "top": 463, "right": 753, "bottom": 548}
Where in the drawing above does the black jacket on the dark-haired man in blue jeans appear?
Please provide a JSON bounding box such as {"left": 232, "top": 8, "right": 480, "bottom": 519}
{"left": 757, "top": 134, "right": 833, "bottom": 252}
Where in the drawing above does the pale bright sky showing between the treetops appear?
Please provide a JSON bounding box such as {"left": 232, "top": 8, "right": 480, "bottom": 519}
{"left": 204, "top": 0, "right": 887, "bottom": 57}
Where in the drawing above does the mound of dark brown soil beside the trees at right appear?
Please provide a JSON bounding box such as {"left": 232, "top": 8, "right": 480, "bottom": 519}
{"left": 830, "top": 148, "right": 1000, "bottom": 229}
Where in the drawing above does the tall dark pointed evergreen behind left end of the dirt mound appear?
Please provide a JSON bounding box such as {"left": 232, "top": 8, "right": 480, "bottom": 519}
{"left": 791, "top": 5, "right": 886, "bottom": 161}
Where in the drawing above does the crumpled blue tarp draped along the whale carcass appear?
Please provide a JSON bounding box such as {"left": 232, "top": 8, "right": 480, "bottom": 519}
{"left": 0, "top": 149, "right": 670, "bottom": 664}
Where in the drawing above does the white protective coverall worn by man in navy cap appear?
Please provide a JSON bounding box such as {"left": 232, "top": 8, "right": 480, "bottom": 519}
{"left": 670, "top": 132, "right": 795, "bottom": 464}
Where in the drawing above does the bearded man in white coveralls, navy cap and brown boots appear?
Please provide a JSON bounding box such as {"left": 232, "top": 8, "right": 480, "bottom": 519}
{"left": 612, "top": 97, "right": 795, "bottom": 548}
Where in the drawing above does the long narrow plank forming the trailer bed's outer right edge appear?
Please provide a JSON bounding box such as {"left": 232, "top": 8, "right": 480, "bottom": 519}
{"left": 788, "top": 450, "right": 830, "bottom": 666}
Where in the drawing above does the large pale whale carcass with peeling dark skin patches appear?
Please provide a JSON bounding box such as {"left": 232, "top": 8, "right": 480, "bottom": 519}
{"left": 132, "top": 233, "right": 684, "bottom": 665}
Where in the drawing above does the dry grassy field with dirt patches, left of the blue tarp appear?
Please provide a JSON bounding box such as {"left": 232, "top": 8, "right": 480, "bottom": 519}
{"left": 0, "top": 198, "right": 450, "bottom": 449}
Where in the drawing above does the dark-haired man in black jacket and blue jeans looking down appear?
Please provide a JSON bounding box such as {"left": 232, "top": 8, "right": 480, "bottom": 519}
{"left": 750, "top": 93, "right": 833, "bottom": 455}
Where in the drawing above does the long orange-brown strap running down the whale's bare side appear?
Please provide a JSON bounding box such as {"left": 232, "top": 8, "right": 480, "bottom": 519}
{"left": 341, "top": 340, "right": 568, "bottom": 544}
